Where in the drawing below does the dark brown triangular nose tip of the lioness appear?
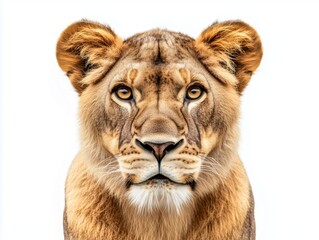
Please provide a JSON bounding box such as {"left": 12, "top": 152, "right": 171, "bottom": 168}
{"left": 136, "top": 139, "right": 183, "bottom": 162}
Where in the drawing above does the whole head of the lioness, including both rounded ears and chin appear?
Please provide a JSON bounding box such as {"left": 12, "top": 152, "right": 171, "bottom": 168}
{"left": 57, "top": 21, "right": 262, "bottom": 212}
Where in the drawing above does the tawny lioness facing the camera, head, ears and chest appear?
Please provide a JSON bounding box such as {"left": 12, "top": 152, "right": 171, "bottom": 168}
{"left": 56, "top": 20, "right": 262, "bottom": 240}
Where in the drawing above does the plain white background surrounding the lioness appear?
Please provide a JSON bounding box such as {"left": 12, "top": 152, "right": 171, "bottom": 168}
{"left": 0, "top": 0, "right": 319, "bottom": 240}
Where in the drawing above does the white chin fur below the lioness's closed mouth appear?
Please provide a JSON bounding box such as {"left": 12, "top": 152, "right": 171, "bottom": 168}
{"left": 128, "top": 182, "right": 192, "bottom": 214}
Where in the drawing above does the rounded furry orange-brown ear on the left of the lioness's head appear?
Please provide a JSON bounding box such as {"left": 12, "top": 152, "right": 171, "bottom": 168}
{"left": 56, "top": 20, "right": 122, "bottom": 93}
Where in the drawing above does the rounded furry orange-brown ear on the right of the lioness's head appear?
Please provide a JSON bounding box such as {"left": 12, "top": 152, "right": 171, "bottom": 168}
{"left": 195, "top": 21, "right": 263, "bottom": 93}
